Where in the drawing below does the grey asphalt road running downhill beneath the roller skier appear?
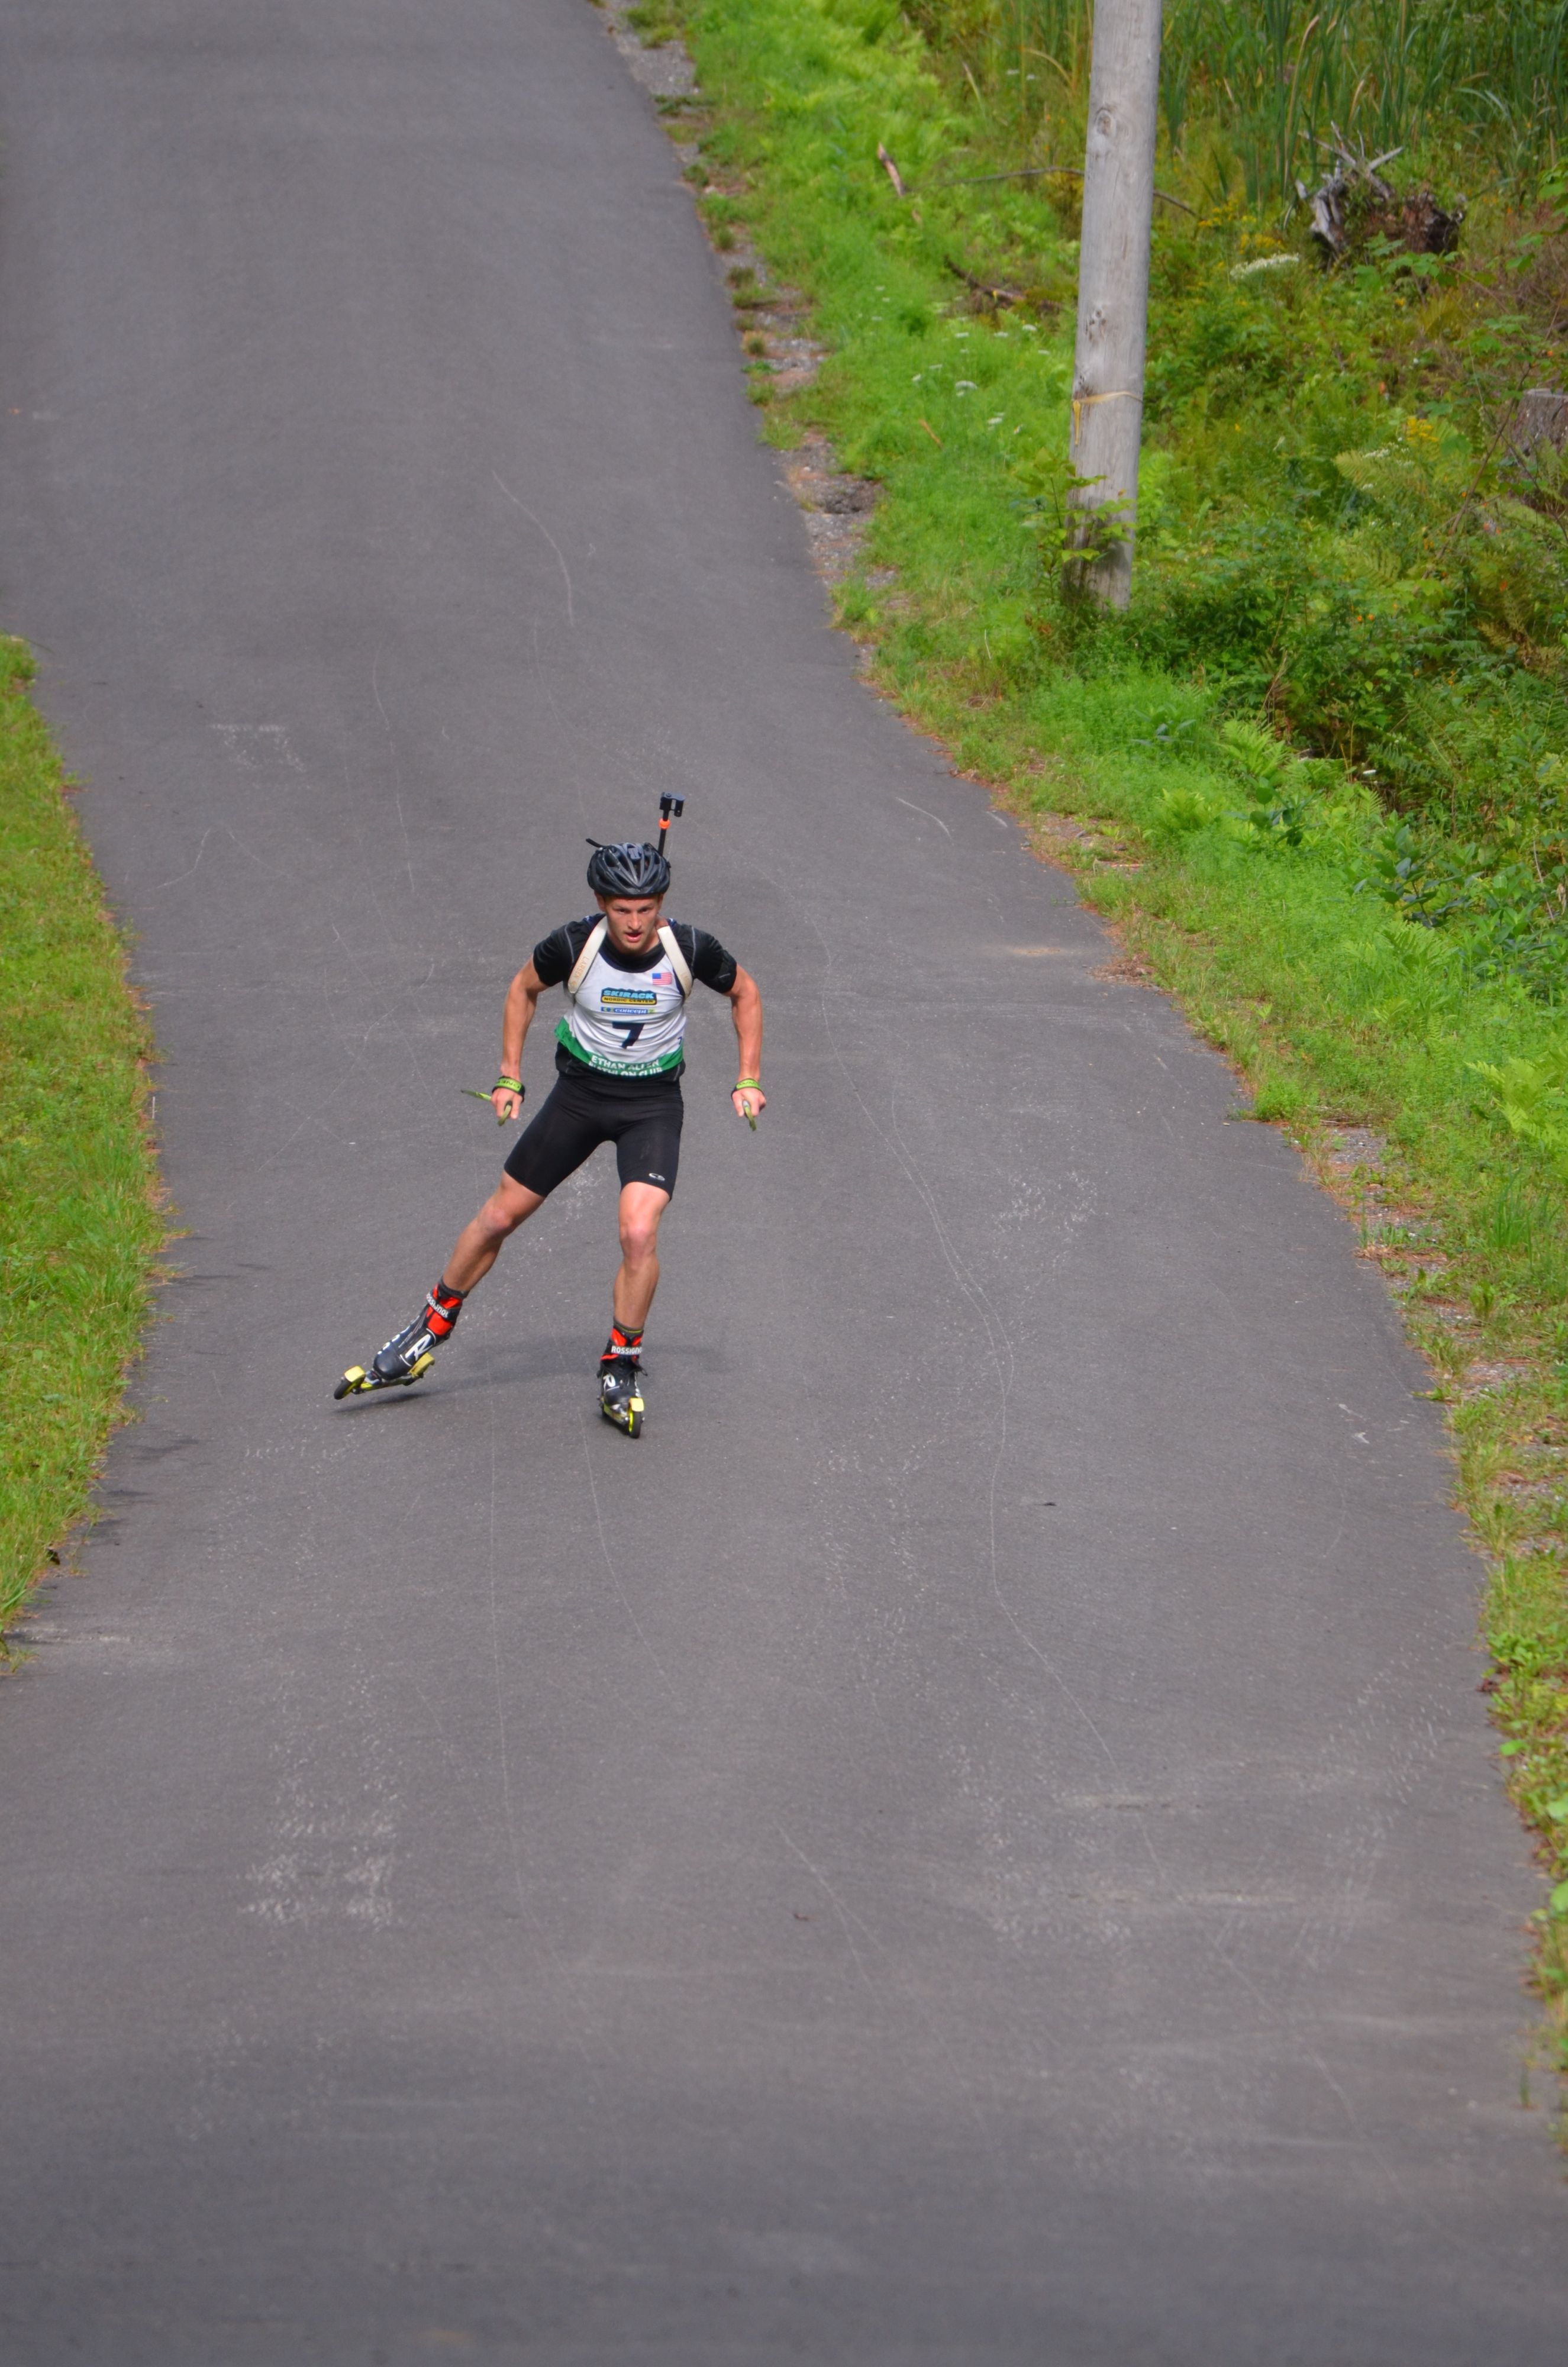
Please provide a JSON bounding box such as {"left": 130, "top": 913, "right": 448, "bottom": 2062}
{"left": 0, "top": 0, "right": 1568, "bottom": 2367}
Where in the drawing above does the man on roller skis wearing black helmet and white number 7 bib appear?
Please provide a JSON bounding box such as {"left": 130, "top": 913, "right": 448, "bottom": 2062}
{"left": 334, "top": 838, "right": 767, "bottom": 1439}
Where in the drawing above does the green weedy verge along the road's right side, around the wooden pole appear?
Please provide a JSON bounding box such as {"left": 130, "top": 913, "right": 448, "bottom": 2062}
{"left": 637, "top": 0, "right": 1568, "bottom": 2111}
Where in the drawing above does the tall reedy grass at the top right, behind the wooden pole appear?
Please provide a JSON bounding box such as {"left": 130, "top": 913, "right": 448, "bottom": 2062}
{"left": 909, "top": 0, "right": 1568, "bottom": 206}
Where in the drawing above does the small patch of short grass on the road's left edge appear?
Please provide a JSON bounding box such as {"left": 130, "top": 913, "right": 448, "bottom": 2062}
{"left": 0, "top": 639, "right": 163, "bottom": 1650}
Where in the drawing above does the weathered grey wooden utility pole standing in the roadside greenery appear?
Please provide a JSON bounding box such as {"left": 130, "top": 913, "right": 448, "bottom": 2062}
{"left": 1068, "top": 0, "right": 1160, "bottom": 608}
